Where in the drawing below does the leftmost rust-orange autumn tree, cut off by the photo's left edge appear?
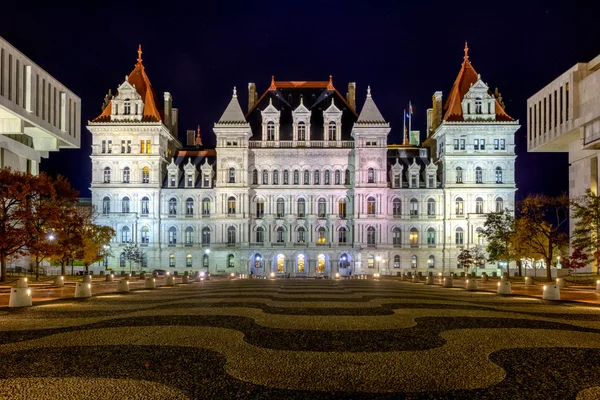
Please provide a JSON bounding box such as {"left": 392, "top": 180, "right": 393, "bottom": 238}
{"left": 0, "top": 168, "right": 32, "bottom": 282}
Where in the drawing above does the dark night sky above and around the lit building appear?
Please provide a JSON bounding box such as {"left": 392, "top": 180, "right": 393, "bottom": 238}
{"left": 0, "top": 0, "right": 600, "bottom": 198}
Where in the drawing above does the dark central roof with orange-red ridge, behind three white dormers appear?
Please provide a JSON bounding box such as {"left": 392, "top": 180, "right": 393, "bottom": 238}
{"left": 246, "top": 77, "right": 358, "bottom": 140}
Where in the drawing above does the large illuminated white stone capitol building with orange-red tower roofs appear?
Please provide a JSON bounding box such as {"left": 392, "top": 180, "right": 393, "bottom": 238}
{"left": 88, "top": 48, "right": 519, "bottom": 277}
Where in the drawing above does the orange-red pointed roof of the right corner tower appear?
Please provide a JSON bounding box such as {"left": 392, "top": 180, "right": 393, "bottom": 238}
{"left": 443, "top": 43, "right": 514, "bottom": 122}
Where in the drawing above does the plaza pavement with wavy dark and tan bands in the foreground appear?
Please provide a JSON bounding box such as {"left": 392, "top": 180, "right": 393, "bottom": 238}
{"left": 0, "top": 280, "right": 600, "bottom": 399}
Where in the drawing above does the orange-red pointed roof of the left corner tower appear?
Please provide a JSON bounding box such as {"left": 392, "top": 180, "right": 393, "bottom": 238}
{"left": 92, "top": 45, "right": 162, "bottom": 122}
